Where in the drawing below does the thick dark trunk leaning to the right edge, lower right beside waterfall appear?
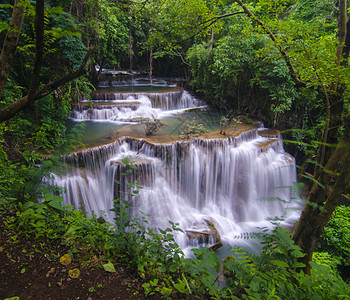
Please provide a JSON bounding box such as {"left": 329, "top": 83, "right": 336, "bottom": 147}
{"left": 292, "top": 118, "right": 350, "bottom": 273}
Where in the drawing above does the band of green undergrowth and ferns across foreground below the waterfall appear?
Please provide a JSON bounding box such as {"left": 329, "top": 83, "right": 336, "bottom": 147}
{"left": 0, "top": 163, "right": 350, "bottom": 299}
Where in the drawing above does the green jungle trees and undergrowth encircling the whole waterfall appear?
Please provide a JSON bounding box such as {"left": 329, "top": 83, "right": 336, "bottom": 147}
{"left": 0, "top": 0, "right": 350, "bottom": 299}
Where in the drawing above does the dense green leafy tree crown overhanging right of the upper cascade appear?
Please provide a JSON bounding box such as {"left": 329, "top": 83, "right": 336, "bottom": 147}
{"left": 186, "top": 17, "right": 297, "bottom": 124}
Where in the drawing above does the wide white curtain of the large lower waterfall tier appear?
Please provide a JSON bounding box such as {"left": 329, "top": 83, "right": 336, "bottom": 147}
{"left": 49, "top": 129, "right": 296, "bottom": 248}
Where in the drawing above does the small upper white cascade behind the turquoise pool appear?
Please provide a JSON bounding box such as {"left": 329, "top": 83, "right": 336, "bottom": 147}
{"left": 72, "top": 90, "right": 201, "bottom": 122}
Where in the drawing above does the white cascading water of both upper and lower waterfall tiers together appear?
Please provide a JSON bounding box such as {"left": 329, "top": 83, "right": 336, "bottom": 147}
{"left": 50, "top": 75, "right": 299, "bottom": 253}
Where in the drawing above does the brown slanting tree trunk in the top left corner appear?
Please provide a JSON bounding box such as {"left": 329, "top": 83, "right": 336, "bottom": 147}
{"left": 0, "top": 0, "right": 28, "bottom": 98}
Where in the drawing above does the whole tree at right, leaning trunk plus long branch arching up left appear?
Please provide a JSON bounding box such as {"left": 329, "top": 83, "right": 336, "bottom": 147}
{"left": 231, "top": 0, "right": 350, "bottom": 272}
